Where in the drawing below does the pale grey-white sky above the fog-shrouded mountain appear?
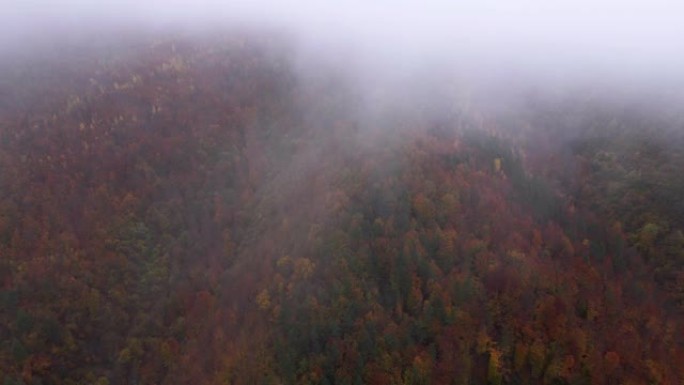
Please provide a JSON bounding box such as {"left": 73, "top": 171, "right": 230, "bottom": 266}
{"left": 0, "top": 0, "right": 684, "bottom": 89}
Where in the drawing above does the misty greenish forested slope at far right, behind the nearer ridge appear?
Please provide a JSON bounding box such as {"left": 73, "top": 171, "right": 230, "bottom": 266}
{"left": 510, "top": 98, "right": 684, "bottom": 314}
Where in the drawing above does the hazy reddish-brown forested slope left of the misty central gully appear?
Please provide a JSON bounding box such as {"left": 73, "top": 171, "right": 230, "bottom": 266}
{"left": 0, "top": 36, "right": 294, "bottom": 383}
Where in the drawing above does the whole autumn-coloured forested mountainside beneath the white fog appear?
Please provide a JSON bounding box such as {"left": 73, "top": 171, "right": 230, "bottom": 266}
{"left": 0, "top": 34, "right": 684, "bottom": 385}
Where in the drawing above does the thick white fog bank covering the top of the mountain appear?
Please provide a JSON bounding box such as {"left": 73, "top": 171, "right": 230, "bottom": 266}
{"left": 0, "top": 0, "right": 684, "bottom": 108}
